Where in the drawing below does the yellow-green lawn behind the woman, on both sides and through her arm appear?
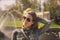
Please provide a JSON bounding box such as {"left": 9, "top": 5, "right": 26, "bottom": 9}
{"left": 5, "top": 20, "right": 60, "bottom": 28}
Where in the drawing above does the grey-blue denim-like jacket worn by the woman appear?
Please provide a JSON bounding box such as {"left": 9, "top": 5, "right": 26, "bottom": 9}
{"left": 12, "top": 18, "right": 51, "bottom": 40}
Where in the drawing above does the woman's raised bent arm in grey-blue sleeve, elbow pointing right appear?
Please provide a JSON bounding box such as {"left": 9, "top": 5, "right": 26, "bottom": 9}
{"left": 38, "top": 17, "right": 51, "bottom": 34}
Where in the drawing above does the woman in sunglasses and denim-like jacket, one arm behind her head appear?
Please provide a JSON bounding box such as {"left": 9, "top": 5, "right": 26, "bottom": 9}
{"left": 12, "top": 9, "right": 50, "bottom": 40}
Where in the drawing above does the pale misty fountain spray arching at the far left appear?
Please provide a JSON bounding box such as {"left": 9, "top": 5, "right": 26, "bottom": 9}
{"left": 0, "top": 11, "right": 16, "bottom": 39}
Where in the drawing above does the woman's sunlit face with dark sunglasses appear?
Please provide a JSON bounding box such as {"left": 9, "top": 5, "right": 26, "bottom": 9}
{"left": 22, "top": 14, "right": 33, "bottom": 28}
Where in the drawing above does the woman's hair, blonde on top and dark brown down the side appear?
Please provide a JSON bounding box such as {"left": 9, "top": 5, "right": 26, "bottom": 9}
{"left": 23, "top": 8, "right": 38, "bottom": 29}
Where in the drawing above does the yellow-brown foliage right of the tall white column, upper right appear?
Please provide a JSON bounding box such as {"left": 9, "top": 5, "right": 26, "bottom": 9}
{"left": 44, "top": 0, "right": 57, "bottom": 19}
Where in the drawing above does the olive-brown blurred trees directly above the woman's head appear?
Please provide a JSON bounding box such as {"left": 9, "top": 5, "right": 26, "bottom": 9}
{"left": 21, "top": 0, "right": 40, "bottom": 10}
